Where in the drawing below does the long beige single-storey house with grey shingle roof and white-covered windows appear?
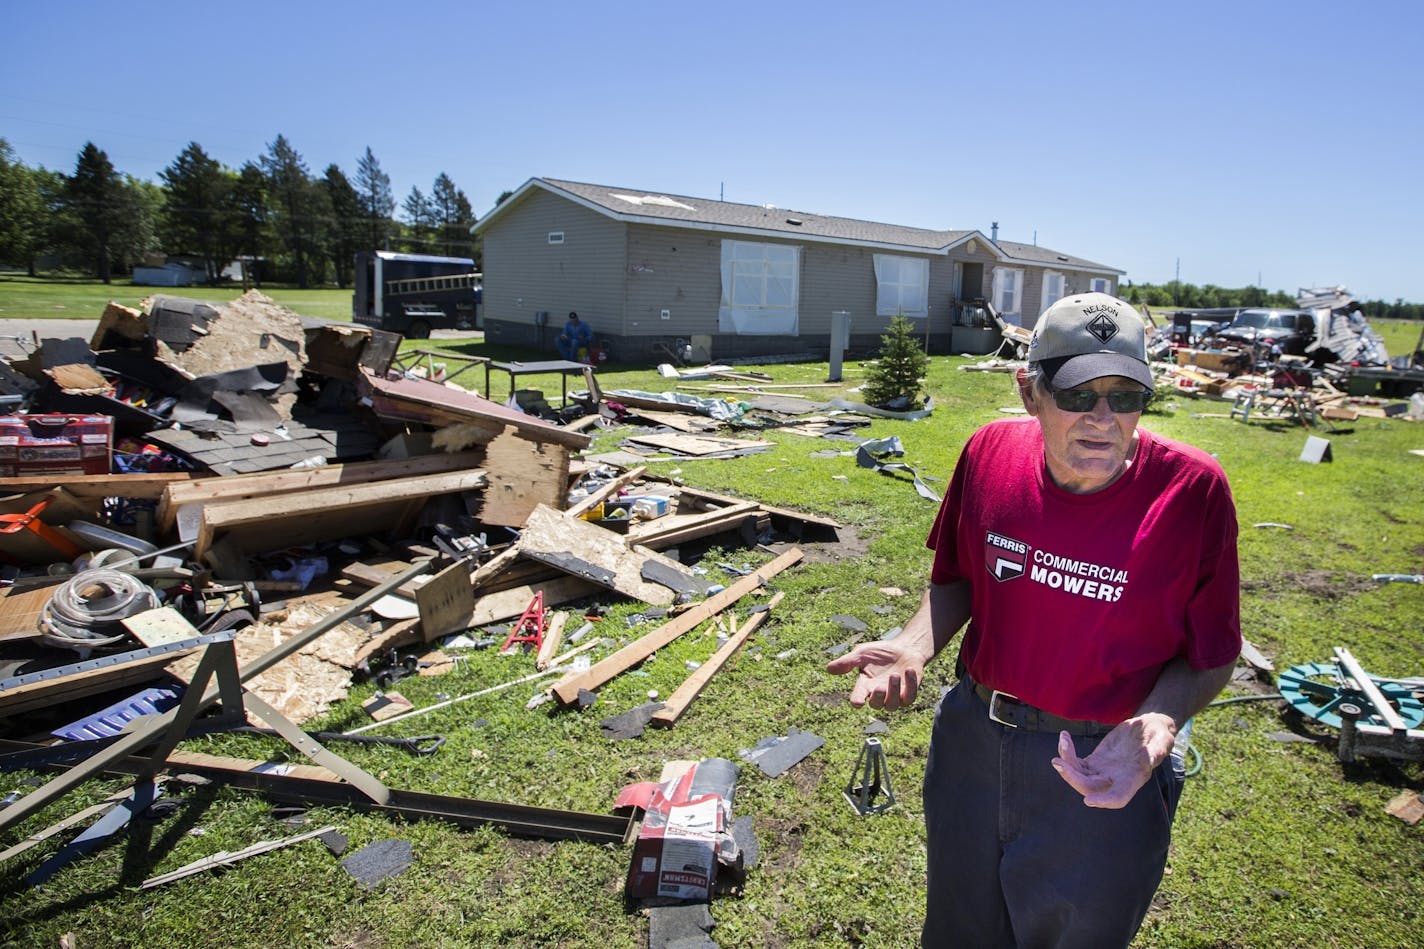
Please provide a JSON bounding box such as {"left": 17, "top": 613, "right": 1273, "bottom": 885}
{"left": 474, "top": 178, "right": 1122, "bottom": 362}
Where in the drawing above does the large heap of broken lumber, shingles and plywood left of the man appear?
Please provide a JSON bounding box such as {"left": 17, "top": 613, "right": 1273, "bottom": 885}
{"left": 0, "top": 287, "right": 843, "bottom": 923}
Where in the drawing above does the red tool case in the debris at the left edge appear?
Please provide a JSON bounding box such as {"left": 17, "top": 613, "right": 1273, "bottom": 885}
{"left": 0, "top": 415, "right": 114, "bottom": 477}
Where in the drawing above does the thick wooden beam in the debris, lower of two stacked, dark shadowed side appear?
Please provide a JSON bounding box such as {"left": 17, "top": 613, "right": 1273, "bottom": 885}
{"left": 194, "top": 470, "right": 486, "bottom": 557}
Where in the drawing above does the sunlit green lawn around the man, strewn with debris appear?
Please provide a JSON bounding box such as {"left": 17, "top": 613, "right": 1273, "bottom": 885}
{"left": 0, "top": 282, "right": 1424, "bottom": 949}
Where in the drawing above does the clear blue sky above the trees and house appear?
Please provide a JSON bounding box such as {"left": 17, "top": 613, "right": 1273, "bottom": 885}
{"left": 8, "top": 0, "right": 1424, "bottom": 302}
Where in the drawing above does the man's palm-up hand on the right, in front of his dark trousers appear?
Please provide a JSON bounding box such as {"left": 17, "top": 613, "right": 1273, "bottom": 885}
{"left": 1052, "top": 714, "right": 1176, "bottom": 808}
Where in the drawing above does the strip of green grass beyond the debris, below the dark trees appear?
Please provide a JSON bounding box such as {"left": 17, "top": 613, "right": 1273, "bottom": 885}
{"left": 0, "top": 274, "right": 352, "bottom": 321}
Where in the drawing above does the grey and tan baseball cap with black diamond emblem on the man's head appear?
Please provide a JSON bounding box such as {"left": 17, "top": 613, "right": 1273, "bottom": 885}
{"left": 1028, "top": 294, "right": 1153, "bottom": 389}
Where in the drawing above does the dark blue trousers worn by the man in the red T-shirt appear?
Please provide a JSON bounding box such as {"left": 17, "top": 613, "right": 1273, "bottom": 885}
{"left": 921, "top": 687, "right": 1185, "bottom": 949}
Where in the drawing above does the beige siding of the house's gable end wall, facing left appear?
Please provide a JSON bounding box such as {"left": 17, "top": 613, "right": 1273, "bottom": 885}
{"left": 483, "top": 191, "right": 628, "bottom": 353}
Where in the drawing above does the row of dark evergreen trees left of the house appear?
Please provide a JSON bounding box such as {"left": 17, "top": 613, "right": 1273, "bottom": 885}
{"left": 0, "top": 135, "right": 492, "bottom": 288}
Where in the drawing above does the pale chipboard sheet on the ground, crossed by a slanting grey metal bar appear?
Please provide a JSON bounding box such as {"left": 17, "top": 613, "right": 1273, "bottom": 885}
{"left": 167, "top": 603, "right": 369, "bottom": 725}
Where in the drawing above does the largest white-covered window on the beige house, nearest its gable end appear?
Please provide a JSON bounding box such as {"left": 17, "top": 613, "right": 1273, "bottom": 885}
{"left": 718, "top": 241, "right": 800, "bottom": 336}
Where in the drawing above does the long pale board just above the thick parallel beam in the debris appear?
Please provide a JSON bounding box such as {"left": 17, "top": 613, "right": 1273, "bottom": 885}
{"left": 159, "top": 450, "right": 484, "bottom": 530}
